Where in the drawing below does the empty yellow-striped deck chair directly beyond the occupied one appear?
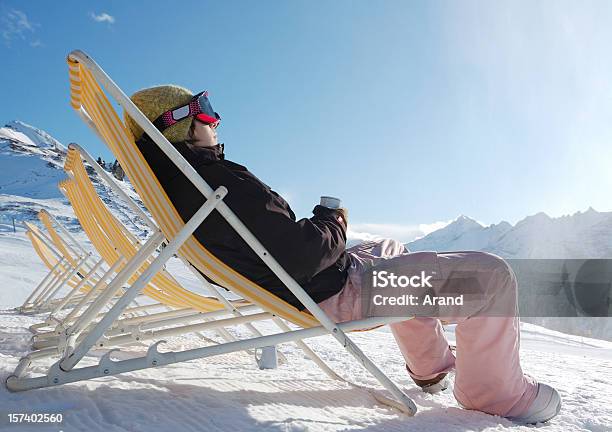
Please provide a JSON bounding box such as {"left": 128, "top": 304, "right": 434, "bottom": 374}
{"left": 8, "top": 173, "right": 264, "bottom": 369}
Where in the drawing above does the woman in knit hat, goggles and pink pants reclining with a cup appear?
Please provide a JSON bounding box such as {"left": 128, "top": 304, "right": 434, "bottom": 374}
{"left": 125, "top": 85, "right": 561, "bottom": 423}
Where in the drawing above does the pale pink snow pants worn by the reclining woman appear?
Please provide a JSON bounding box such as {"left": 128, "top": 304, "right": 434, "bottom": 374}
{"left": 319, "top": 239, "right": 537, "bottom": 417}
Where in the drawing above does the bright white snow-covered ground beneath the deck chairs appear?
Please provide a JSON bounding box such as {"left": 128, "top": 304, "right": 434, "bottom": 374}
{"left": 0, "top": 232, "right": 612, "bottom": 432}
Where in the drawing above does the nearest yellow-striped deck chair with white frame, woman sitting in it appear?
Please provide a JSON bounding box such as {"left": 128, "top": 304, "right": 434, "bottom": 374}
{"left": 7, "top": 51, "right": 417, "bottom": 415}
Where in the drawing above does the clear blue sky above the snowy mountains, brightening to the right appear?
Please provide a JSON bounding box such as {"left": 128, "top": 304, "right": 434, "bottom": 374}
{"left": 0, "top": 0, "right": 612, "bottom": 241}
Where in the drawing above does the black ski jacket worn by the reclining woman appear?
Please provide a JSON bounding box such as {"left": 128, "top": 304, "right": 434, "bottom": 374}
{"left": 136, "top": 134, "right": 349, "bottom": 310}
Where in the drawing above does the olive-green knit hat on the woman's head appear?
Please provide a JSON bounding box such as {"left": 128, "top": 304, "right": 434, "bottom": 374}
{"left": 123, "top": 85, "right": 193, "bottom": 143}
